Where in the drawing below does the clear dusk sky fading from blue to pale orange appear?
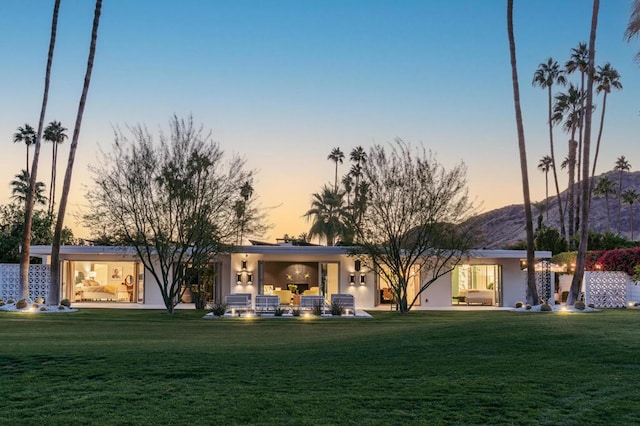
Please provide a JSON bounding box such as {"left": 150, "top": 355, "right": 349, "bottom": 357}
{"left": 0, "top": 0, "right": 640, "bottom": 241}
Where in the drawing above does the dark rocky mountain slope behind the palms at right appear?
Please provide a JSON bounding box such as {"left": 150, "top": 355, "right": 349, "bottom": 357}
{"left": 477, "top": 171, "right": 640, "bottom": 249}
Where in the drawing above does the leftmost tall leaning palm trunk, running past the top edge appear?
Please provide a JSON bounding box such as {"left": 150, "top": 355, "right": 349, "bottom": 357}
{"left": 20, "top": 0, "right": 60, "bottom": 298}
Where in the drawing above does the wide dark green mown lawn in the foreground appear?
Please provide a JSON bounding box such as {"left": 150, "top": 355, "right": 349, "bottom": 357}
{"left": 0, "top": 309, "right": 640, "bottom": 425}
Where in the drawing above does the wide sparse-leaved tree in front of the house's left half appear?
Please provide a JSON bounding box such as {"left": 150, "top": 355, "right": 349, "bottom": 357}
{"left": 85, "top": 116, "right": 261, "bottom": 314}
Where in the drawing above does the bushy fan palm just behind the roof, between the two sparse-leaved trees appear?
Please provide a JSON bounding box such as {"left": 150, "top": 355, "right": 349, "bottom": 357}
{"left": 304, "top": 185, "right": 345, "bottom": 246}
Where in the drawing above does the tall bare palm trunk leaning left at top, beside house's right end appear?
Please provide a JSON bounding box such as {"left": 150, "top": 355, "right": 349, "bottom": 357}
{"left": 507, "top": 0, "right": 536, "bottom": 305}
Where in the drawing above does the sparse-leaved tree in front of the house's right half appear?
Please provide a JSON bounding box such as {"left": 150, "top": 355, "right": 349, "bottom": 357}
{"left": 347, "top": 139, "right": 479, "bottom": 314}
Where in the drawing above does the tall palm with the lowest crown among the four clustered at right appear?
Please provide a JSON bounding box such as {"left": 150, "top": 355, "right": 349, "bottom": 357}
{"left": 553, "top": 84, "right": 583, "bottom": 244}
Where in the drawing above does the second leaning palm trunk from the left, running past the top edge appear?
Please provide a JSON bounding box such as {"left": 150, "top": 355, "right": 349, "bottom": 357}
{"left": 49, "top": 0, "right": 102, "bottom": 304}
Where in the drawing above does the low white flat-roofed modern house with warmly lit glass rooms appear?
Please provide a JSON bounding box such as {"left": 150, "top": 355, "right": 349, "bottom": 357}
{"left": 25, "top": 243, "right": 551, "bottom": 309}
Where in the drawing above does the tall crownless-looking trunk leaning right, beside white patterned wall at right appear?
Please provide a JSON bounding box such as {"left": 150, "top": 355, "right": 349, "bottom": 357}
{"left": 567, "top": 0, "right": 600, "bottom": 305}
